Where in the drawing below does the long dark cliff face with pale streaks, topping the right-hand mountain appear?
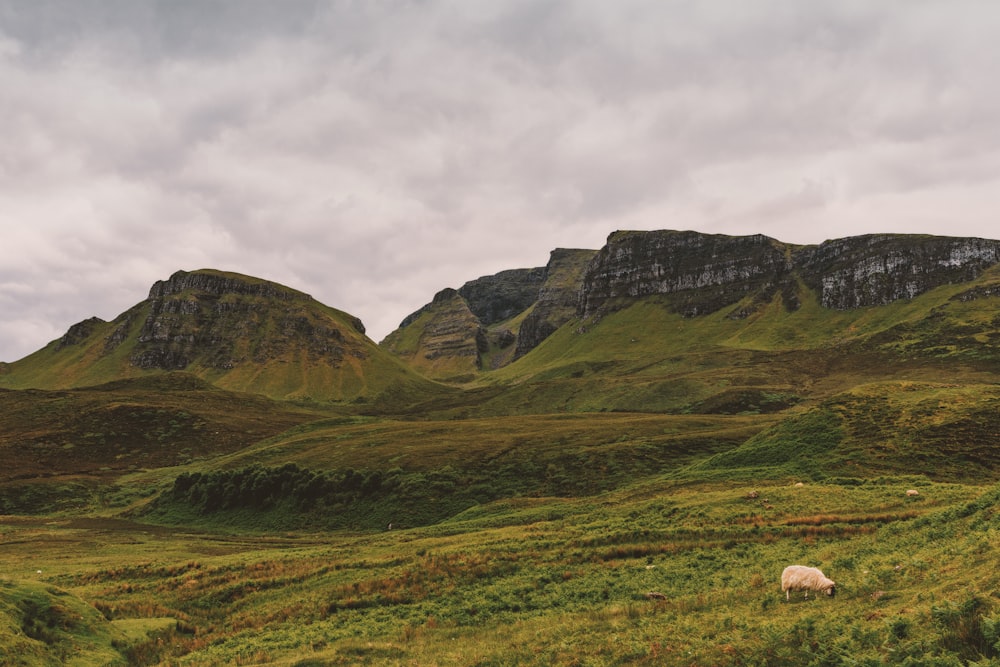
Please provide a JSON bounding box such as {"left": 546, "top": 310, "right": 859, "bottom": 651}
{"left": 577, "top": 231, "right": 1000, "bottom": 319}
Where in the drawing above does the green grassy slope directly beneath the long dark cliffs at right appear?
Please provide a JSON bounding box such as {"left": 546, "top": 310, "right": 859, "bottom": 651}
{"left": 466, "top": 270, "right": 1000, "bottom": 415}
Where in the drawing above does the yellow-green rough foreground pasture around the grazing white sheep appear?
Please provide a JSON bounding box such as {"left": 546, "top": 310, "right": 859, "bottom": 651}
{"left": 0, "top": 478, "right": 1000, "bottom": 665}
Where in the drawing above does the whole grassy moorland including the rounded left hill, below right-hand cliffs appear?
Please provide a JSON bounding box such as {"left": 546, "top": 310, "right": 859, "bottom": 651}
{"left": 0, "top": 231, "right": 1000, "bottom": 667}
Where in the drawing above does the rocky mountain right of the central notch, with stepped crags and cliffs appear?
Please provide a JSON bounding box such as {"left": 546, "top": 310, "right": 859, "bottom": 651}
{"left": 382, "top": 230, "right": 1000, "bottom": 380}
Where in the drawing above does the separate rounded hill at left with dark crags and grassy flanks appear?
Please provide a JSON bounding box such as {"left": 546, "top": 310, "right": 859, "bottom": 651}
{"left": 0, "top": 269, "right": 438, "bottom": 401}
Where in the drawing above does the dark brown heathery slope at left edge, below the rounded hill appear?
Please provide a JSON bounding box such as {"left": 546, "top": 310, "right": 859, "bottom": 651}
{"left": 0, "top": 373, "right": 322, "bottom": 512}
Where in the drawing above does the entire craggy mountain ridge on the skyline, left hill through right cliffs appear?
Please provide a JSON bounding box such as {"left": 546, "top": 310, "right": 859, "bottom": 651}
{"left": 0, "top": 230, "right": 1000, "bottom": 408}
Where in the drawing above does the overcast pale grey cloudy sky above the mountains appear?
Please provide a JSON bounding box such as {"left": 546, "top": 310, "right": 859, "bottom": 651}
{"left": 0, "top": 0, "right": 1000, "bottom": 361}
